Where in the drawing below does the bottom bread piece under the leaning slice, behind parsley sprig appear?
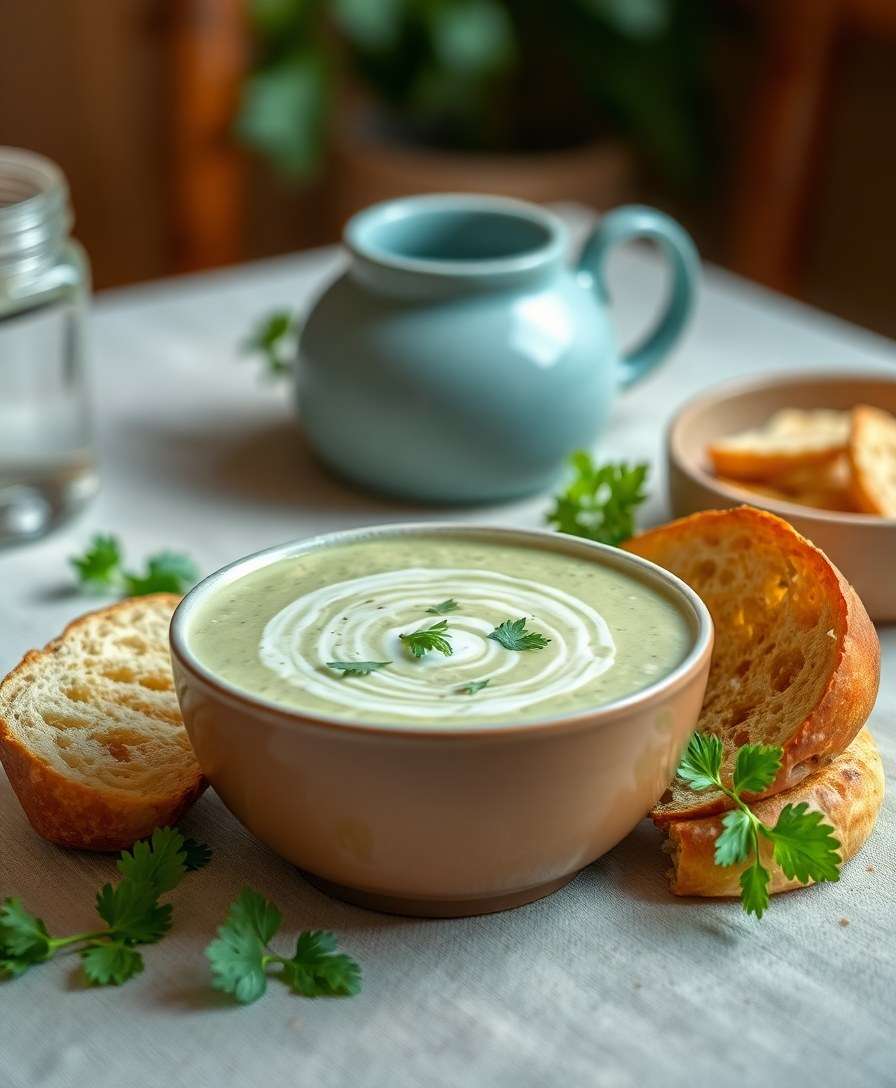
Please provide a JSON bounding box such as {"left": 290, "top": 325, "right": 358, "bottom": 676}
{"left": 667, "top": 729, "right": 884, "bottom": 897}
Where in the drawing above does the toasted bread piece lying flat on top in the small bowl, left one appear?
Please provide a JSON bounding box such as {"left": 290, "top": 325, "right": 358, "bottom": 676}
{"left": 708, "top": 408, "right": 849, "bottom": 481}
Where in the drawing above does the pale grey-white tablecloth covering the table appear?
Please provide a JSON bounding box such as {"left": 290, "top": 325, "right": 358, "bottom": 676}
{"left": 0, "top": 210, "right": 896, "bottom": 1088}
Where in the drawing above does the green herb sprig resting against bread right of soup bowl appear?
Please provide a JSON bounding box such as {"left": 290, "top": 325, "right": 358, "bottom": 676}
{"left": 679, "top": 733, "right": 841, "bottom": 918}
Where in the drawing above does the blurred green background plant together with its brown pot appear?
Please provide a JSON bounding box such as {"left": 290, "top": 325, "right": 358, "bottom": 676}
{"left": 238, "top": 0, "right": 706, "bottom": 221}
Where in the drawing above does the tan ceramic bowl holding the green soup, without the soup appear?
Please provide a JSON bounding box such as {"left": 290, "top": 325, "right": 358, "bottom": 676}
{"left": 171, "top": 524, "right": 712, "bottom": 917}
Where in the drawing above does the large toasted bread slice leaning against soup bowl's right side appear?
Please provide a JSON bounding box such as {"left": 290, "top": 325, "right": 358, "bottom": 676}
{"left": 625, "top": 506, "right": 880, "bottom": 824}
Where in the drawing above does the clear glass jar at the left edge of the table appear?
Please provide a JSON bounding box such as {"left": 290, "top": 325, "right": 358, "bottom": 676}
{"left": 0, "top": 147, "right": 97, "bottom": 545}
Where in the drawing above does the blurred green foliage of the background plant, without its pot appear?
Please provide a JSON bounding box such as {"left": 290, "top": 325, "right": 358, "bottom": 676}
{"left": 237, "top": 0, "right": 708, "bottom": 183}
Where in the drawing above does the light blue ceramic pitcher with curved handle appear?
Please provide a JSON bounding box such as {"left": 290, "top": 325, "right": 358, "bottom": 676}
{"left": 297, "top": 194, "right": 698, "bottom": 503}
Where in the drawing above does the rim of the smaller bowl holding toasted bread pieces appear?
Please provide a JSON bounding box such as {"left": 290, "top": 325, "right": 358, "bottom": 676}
{"left": 665, "top": 369, "right": 896, "bottom": 532}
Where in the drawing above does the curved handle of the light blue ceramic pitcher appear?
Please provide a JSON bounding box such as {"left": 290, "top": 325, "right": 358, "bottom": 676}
{"left": 578, "top": 205, "right": 700, "bottom": 388}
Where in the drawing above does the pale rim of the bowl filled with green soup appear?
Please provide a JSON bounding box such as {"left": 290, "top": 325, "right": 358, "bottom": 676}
{"left": 170, "top": 521, "right": 714, "bottom": 742}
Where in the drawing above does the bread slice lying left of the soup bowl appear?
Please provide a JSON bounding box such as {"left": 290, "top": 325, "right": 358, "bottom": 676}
{"left": 0, "top": 593, "right": 206, "bottom": 850}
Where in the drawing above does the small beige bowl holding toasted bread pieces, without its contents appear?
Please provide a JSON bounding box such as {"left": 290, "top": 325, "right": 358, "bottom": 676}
{"left": 667, "top": 372, "right": 896, "bottom": 621}
